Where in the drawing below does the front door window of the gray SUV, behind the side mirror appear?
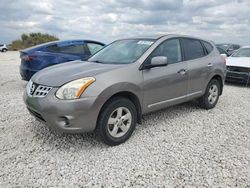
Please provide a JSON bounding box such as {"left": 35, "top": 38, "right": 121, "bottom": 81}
{"left": 147, "top": 39, "right": 182, "bottom": 64}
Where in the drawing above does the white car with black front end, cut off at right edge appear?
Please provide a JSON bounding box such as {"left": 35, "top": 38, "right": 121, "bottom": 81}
{"left": 226, "top": 46, "right": 250, "bottom": 85}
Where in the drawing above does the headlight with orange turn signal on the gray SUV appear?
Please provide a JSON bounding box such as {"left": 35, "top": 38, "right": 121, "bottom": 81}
{"left": 56, "top": 77, "right": 95, "bottom": 100}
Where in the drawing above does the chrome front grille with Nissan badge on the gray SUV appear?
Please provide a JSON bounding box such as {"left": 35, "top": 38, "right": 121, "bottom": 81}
{"left": 27, "top": 81, "right": 52, "bottom": 97}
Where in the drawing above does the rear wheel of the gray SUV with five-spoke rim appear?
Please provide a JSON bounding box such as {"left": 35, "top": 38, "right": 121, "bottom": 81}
{"left": 198, "top": 79, "right": 221, "bottom": 109}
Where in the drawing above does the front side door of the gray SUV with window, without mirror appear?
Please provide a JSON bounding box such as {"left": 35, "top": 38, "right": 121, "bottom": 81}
{"left": 143, "top": 38, "right": 187, "bottom": 111}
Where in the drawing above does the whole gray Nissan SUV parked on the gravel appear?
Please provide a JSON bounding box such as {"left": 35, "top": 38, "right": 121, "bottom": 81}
{"left": 24, "top": 34, "right": 226, "bottom": 145}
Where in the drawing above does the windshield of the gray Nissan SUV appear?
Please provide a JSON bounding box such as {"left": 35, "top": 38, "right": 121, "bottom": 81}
{"left": 88, "top": 39, "right": 155, "bottom": 64}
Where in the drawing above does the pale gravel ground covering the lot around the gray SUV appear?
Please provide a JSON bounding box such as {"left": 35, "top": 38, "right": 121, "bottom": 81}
{"left": 0, "top": 52, "right": 250, "bottom": 187}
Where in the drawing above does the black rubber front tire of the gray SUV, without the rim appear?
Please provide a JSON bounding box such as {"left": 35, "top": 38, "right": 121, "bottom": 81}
{"left": 96, "top": 97, "right": 137, "bottom": 146}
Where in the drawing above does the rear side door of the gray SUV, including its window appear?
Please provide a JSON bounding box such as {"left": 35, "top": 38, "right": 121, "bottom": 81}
{"left": 181, "top": 38, "right": 213, "bottom": 97}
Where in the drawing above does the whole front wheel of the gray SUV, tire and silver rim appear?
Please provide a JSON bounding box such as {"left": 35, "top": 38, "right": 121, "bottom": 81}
{"left": 96, "top": 97, "right": 137, "bottom": 146}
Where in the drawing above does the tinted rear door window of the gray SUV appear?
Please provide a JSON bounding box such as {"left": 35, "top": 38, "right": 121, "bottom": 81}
{"left": 182, "top": 38, "right": 205, "bottom": 60}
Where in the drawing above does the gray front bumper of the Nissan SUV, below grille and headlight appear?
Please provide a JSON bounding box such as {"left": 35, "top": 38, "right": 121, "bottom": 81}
{"left": 23, "top": 88, "right": 100, "bottom": 133}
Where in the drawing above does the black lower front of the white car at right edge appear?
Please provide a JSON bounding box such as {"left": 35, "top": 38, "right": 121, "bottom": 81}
{"left": 226, "top": 71, "right": 250, "bottom": 85}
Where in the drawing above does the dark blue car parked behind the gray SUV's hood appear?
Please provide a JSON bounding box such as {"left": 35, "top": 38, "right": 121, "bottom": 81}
{"left": 20, "top": 40, "right": 105, "bottom": 81}
